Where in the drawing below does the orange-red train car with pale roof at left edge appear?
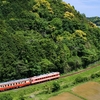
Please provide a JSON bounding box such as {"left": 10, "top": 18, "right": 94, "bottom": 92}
{"left": 0, "top": 78, "right": 31, "bottom": 91}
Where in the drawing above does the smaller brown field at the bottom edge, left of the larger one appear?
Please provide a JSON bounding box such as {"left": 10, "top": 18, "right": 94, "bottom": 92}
{"left": 49, "top": 92, "right": 82, "bottom": 100}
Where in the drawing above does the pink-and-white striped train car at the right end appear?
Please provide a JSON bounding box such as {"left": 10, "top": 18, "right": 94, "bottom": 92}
{"left": 30, "top": 72, "right": 60, "bottom": 84}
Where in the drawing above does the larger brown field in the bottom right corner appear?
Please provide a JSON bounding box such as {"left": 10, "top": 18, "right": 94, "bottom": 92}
{"left": 72, "top": 82, "right": 100, "bottom": 100}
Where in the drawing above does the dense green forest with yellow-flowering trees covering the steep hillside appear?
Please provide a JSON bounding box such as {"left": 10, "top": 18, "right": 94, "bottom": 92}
{"left": 0, "top": 0, "right": 100, "bottom": 82}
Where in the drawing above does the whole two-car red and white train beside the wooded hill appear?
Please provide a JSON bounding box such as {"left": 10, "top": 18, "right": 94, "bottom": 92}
{"left": 0, "top": 72, "right": 60, "bottom": 92}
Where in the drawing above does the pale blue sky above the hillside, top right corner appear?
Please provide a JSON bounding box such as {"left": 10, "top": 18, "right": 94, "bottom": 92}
{"left": 63, "top": 0, "right": 100, "bottom": 17}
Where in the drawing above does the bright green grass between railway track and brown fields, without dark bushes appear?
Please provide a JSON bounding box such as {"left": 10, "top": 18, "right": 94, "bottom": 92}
{"left": 0, "top": 61, "right": 100, "bottom": 100}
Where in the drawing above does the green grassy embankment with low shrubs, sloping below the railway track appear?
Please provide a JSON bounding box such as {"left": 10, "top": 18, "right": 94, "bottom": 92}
{"left": 0, "top": 61, "right": 100, "bottom": 100}
